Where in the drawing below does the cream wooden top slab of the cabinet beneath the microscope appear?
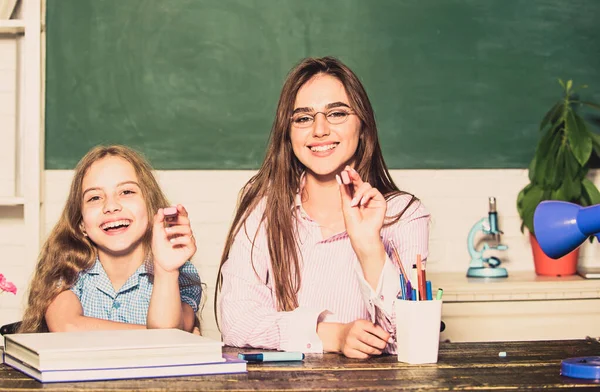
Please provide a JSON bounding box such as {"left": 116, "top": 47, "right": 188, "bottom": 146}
{"left": 427, "top": 271, "right": 600, "bottom": 303}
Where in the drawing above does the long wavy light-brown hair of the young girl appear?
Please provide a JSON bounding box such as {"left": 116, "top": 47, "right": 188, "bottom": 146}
{"left": 19, "top": 146, "right": 169, "bottom": 332}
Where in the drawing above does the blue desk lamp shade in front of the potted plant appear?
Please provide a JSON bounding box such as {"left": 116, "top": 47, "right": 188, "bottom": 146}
{"left": 533, "top": 200, "right": 600, "bottom": 259}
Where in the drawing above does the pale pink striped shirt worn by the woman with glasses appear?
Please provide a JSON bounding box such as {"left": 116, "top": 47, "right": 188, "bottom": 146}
{"left": 219, "top": 188, "right": 429, "bottom": 353}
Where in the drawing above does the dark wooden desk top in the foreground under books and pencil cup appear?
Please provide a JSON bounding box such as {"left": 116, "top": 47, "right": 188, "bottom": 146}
{"left": 0, "top": 339, "right": 600, "bottom": 392}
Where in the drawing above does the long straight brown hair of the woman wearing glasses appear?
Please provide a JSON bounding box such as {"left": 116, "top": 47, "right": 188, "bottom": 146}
{"left": 215, "top": 57, "right": 416, "bottom": 320}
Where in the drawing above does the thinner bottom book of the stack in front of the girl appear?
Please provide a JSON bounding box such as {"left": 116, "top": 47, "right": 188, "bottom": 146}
{"left": 4, "top": 355, "right": 247, "bottom": 382}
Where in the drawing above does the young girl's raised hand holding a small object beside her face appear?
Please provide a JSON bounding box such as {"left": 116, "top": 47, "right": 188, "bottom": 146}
{"left": 152, "top": 204, "right": 196, "bottom": 272}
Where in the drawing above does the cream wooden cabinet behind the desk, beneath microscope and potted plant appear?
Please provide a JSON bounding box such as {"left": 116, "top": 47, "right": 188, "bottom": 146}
{"left": 427, "top": 271, "right": 600, "bottom": 342}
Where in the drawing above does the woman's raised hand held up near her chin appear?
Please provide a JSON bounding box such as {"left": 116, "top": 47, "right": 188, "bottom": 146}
{"left": 338, "top": 166, "right": 387, "bottom": 262}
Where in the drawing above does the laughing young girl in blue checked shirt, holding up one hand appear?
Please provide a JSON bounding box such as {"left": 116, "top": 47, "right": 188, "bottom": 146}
{"left": 19, "top": 146, "right": 201, "bottom": 332}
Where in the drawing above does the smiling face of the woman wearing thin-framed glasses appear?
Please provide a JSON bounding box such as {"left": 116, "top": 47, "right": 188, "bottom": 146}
{"left": 290, "top": 74, "right": 361, "bottom": 180}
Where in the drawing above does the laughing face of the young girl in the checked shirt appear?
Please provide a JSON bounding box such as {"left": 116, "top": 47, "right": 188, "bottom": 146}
{"left": 81, "top": 156, "right": 149, "bottom": 259}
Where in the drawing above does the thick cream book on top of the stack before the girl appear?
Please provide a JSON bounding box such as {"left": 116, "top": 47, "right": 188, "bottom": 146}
{"left": 4, "top": 329, "right": 224, "bottom": 371}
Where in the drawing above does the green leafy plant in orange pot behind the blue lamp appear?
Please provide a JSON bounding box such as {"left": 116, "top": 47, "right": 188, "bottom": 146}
{"left": 517, "top": 79, "right": 600, "bottom": 276}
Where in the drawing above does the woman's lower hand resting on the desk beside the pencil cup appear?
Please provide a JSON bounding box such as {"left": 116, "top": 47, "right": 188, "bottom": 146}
{"left": 332, "top": 320, "right": 390, "bottom": 359}
